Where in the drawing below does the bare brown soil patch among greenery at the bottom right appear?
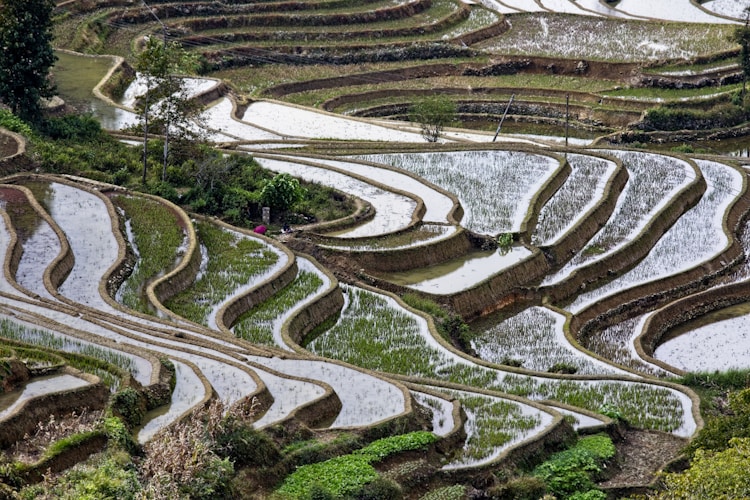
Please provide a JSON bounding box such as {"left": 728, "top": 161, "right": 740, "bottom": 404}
{"left": 599, "top": 429, "right": 687, "bottom": 488}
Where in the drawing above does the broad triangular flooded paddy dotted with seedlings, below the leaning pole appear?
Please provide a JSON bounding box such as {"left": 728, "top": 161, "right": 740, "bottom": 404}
{"left": 360, "top": 151, "right": 559, "bottom": 235}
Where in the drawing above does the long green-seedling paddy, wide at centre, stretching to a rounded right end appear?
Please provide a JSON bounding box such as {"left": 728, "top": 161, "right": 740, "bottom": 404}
{"left": 307, "top": 288, "right": 695, "bottom": 436}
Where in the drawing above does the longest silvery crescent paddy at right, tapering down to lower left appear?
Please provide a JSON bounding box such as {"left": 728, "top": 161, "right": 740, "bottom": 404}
{"left": 568, "top": 160, "right": 743, "bottom": 313}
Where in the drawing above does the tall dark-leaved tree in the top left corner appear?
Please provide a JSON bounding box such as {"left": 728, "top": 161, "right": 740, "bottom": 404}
{"left": 0, "top": 0, "right": 57, "bottom": 123}
